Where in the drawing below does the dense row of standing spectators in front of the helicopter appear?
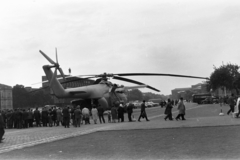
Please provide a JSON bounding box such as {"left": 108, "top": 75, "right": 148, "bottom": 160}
{"left": 0, "top": 100, "right": 137, "bottom": 129}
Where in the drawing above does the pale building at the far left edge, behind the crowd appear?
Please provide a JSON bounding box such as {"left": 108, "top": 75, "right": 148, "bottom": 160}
{"left": 0, "top": 84, "right": 13, "bottom": 109}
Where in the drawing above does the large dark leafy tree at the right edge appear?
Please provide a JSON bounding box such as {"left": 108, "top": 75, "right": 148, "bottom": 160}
{"left": 207, "top": 64, "right": 240, "bottom": 94}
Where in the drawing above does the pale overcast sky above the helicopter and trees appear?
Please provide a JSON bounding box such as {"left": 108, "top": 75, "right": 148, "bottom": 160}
{"left": 0, "top": 0, "right": 240, "bottom": 95}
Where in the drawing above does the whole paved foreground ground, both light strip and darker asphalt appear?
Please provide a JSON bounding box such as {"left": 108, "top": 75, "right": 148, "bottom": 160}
{"left": 0, "top": 103, "right": 240, "bottom": 159}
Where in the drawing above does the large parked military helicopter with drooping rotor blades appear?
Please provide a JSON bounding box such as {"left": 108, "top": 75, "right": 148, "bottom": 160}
{"left": 39, "top": 49, "right": 208, "bottom": 108}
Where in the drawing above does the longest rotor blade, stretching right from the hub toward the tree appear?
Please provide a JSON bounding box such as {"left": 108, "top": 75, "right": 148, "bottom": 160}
{"left": 113, "top": 73, "right": 209, "bottom": 79}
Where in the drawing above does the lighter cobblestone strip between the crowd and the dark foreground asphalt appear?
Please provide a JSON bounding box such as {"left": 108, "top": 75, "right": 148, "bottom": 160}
{"left": 0, "top": 105, "right": 240, "bottom": 153}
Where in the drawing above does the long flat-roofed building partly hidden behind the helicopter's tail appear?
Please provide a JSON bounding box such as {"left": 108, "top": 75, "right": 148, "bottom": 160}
{"left": 42, "top": 75, "right": 94, "bottom": 106}
